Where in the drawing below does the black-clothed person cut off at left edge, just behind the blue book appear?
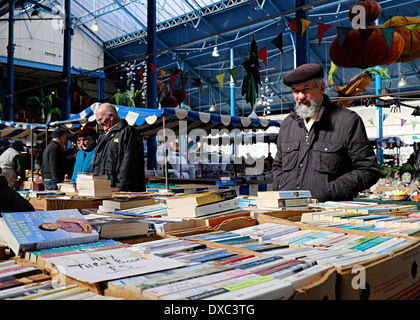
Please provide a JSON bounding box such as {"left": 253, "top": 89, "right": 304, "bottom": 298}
{"left": 0, "top": 168, "right": 35, "bottom": 215}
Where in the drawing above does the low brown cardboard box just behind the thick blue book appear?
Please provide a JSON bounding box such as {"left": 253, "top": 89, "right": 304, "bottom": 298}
{"left": 29, "top": 197, "right": 102, "bottom": 211}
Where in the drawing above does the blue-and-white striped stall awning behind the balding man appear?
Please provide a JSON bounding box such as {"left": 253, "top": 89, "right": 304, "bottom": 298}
{"left": 48, "top": 103, "right": 280, "bottom": 136}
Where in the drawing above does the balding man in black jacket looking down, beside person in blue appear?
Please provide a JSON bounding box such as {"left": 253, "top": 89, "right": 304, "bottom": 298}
{"left": 91, "top": 103, "right": 146, "bottom": 191}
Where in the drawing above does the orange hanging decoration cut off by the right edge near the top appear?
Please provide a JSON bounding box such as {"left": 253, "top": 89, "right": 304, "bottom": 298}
{"left": 383, "top": 16, "right": 420, "bottom": 62}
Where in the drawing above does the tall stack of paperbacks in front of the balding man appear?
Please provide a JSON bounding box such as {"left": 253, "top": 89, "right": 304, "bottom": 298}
{"left": 76, "top": 173, "right": 112, "bottom": 198}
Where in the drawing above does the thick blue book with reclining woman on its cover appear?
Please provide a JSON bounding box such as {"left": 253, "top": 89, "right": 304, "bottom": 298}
{"left": 0, "top": 209, "right": 99, "bottom": 255}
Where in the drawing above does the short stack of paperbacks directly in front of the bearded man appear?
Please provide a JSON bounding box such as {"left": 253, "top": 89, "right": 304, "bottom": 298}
{"left": 256, "top": 190, "right": 311, "bottom": 209}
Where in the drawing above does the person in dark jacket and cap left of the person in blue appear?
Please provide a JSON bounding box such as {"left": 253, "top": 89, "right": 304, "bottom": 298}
{"left": 41, "top": 129, "right": 67, "bottom": 190}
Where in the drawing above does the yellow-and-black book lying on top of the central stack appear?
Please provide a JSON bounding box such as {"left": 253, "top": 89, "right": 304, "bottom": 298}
{"left": 166, "top": 189, "right": 237, "bottom": 208}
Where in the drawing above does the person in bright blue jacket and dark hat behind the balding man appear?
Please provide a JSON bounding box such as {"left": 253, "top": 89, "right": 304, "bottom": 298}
{"left": 70, "top": 126, "right": 98, "bottom": 183}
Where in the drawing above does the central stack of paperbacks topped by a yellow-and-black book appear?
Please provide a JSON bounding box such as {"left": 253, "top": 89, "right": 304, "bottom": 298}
{"left": 166, "top": 189, "right": 239, "bottom": 218}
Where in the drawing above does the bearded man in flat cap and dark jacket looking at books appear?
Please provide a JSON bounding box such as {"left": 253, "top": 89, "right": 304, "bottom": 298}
{"left": 272, "top": 63, "right": 380, "bottom": 202}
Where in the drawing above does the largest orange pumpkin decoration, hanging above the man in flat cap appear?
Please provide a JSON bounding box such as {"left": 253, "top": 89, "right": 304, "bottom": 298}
{"left": 329, "top": 1, "right": 405, "bottom": 69}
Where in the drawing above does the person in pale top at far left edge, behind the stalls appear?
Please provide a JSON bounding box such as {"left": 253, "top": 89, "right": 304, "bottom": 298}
{"left": 0, "top": 141, "right": 26, "bottom": 188}
